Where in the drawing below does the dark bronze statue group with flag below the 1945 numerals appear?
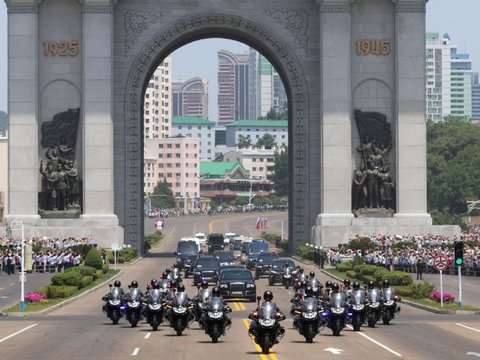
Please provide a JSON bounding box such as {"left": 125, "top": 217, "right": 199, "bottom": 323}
{"left": 352, "top": 110, "right": 395, "bottom": 211}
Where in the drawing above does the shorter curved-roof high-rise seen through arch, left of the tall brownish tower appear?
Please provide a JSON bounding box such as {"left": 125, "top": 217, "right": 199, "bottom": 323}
{"left": 172, "top": 77, "right": 208, "bottom": 119}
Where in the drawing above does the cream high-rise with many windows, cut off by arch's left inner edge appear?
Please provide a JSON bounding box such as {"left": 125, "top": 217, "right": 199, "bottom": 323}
{"left": 143, "top": 57, "right": 172, "bottom": 139}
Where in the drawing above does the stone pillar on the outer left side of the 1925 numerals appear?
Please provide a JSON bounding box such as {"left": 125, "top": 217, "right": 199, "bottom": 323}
{"left": 6, "top": 0, "right": 40, "bottom": 224}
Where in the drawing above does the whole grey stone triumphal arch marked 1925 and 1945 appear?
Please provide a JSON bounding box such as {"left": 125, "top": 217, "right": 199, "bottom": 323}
{"left": 6, "top": 0, "right": 456, "bottom": 250}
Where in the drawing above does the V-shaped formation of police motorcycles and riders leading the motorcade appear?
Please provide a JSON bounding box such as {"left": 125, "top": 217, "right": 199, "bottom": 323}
{"left": 102, "top": 258, "right": 401, "bottom": 354}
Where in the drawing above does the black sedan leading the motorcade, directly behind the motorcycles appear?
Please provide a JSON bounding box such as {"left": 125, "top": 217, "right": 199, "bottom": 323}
{"left": 218, "top": 269, "right": 257, "bottom": 302}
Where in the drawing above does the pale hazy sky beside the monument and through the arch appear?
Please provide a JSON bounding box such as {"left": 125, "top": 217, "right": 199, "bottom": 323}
{"left": 0, "top": 0, "right": 480, "bottom": 116}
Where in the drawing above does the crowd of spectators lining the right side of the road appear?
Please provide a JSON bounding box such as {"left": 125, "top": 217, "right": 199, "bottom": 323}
{"left": 327, "top": 225, "right": 480, "bottom": 279}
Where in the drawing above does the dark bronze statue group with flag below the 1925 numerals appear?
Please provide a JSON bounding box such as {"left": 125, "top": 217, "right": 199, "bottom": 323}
{"left": 39, "top": 109, "right": 82, "bottom": 211}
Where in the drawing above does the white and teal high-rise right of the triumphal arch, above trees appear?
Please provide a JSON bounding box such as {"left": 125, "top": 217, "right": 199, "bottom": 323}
{"left": 425, "top": 33, "right": 472, "bottom": 121}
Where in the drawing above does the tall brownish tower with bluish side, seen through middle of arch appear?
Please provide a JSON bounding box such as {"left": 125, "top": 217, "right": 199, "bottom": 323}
{"left": 217, "top": 50, "right": 250, "bottom": 125}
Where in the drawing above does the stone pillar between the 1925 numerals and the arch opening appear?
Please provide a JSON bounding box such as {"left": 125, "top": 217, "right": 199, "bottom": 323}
{"left": 80, "top": 0, "right": 118, "bottom": 225}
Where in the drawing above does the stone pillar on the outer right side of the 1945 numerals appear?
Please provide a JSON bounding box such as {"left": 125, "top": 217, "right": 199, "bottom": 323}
{"left": 392, "top": 0, "right": 432, "bottom": 225}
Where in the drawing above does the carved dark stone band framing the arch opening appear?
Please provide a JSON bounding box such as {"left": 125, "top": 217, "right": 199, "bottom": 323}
{"left": 120, "top": 13, "right": 309, "bottom": 251}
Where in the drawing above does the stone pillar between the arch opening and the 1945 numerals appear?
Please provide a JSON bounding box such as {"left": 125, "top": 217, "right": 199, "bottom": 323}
{"left": 316, "top": 0, "right": 353, "bottom": 226}
